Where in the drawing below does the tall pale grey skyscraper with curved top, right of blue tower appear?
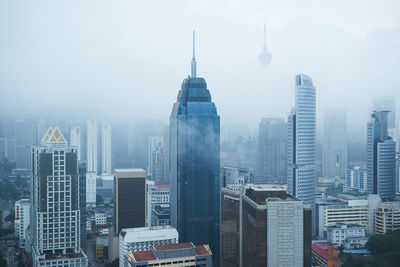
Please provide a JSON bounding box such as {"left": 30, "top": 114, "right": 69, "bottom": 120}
{"left": 287, "top": 74, "right": 316, "bottom": 233}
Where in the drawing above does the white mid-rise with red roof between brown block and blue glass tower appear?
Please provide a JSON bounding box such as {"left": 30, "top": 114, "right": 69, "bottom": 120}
{"left": 146, "top": 184, "right": 170, "bottom": 226}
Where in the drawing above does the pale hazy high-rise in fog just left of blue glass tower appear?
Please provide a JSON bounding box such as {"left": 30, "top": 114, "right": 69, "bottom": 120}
{"left": 147, "top": 136, "right": 164, "bottom": 184}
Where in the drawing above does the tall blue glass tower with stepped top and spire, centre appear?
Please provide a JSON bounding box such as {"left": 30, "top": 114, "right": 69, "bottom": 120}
{"left": 170, "top": 33, "right": 221, "bottom": 266}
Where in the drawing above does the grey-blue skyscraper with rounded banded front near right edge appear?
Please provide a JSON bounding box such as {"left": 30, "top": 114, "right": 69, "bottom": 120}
{"left": 367, "top": 111, "right": 396, "bottom": 201}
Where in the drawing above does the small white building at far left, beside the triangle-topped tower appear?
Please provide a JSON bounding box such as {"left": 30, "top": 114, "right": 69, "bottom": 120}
{"left": 14, "top": 199, "right": 30, "bottom": 248}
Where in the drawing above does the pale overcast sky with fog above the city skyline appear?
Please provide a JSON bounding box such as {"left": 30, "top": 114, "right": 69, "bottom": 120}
{"left": 0, "top": 0, "right": 400, "bottom": 137}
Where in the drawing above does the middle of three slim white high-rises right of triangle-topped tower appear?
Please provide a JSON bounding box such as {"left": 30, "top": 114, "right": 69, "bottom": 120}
{"left": 86, "top": 118, "right": 97, "bottom": 174}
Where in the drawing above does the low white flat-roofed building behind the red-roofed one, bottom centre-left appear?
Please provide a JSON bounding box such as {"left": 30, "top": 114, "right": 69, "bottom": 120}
{"left": 119, "top": 226, "right": 179, "bottom": 266}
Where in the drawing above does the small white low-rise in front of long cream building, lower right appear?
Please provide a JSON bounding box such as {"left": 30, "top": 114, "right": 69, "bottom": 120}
{"left": 327, "top": 223, "right": 368, "bottom": 249}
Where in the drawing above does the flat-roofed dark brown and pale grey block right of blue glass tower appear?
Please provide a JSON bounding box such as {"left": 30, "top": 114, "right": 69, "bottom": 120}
{"left": 221, "top": 184, "right": 312, "bottom": 266}
